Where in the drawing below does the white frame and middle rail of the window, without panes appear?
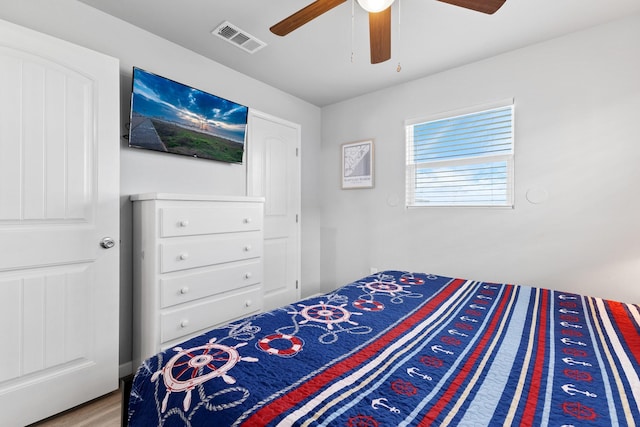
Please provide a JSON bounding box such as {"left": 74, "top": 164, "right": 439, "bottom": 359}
{"left": 404, "top": 98, "right": 515, "bottom": 209}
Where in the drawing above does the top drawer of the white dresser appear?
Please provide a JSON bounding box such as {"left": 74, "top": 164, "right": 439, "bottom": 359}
{"left": 160, "top": 203, "right": 262, "bottom": 237}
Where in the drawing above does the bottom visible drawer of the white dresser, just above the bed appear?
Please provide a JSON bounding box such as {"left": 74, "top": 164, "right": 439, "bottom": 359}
{"left": 160, "top": 287, "right": 262, "bottom": 342}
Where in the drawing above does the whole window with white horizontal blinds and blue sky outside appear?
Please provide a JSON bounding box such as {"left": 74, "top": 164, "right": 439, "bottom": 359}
{"left": 405, "top": 100, "right": 513, "bottom": 207}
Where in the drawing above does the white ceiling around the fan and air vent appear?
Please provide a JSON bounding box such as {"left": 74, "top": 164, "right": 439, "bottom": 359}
{"left": 81, "top": 0, "right": 640, "bottom": 106}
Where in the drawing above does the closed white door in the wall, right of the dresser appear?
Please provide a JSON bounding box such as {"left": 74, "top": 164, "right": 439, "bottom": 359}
{"left": 247, "top": 111, "right": 300, "bottom": 310}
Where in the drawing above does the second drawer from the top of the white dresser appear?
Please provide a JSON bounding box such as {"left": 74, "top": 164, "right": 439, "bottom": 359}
{"left": 160, "top": 231, "right": 263, "bottom": 273}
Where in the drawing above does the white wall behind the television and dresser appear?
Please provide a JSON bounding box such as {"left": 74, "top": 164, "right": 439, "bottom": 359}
{"left": 0, "top": 0, "right": 321, "bottom": 369}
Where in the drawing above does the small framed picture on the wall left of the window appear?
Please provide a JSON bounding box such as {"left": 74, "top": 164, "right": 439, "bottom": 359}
{"left": 342, "top": 139, "right": 373, "bottom": 190}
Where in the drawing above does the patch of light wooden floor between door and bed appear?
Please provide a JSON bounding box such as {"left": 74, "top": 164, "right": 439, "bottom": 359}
{"left": 30, "top": 390, "right": 122, "bottom": 427}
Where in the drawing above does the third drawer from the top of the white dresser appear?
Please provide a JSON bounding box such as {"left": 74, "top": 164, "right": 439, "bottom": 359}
{"left": 160, "top": 259, "right": 262, "bottom": 308}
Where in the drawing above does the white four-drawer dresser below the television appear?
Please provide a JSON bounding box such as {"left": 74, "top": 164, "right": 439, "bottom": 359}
{"left": 131, "top": 193, "right": 264, "bottom": 366}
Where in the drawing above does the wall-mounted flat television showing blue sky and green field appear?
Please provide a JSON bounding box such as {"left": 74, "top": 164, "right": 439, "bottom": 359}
{"left": 129, "top": 67, "right": 248, "bottom": 163}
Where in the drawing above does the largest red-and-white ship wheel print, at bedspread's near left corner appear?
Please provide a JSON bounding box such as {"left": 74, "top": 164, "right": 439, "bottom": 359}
{"left": 151, "top": 338, "right": 258, "bottom": 413}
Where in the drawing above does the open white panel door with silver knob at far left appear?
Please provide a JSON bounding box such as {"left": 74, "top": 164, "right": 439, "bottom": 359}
{"left": 0, "top": 21, "right": 119, "bottom": 426}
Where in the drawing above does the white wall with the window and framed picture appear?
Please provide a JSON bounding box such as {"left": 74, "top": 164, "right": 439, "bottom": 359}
{"left": 321, "top": 15, "right": 640, "bottom": 303}
